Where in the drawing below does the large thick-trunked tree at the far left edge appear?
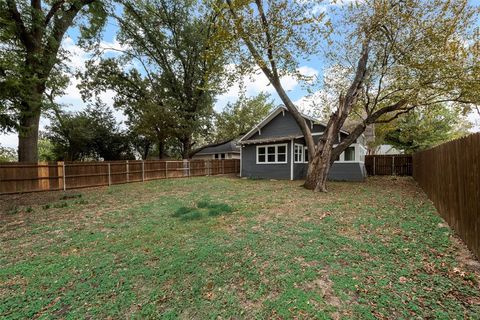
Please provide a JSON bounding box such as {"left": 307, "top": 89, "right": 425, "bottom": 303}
{"left": 0, "top": 0, "right": 106, "bottom": 162}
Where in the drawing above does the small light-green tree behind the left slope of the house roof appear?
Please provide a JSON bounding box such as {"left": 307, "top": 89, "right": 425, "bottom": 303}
{"left": 215, "top": 93, "right": 274, "bottom": 142}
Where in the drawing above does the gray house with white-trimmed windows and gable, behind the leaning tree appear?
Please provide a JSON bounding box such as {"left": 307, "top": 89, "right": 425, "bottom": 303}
{"left": 238, "top": 106, "right": 367, "bottom": 181}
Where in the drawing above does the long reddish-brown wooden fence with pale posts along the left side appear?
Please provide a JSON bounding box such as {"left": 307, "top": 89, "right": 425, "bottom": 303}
{"left": 0, "top": 159, "right": 240, "bottom": 194}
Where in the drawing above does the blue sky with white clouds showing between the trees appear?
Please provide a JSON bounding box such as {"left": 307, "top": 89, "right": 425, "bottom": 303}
{"left": 0, "top": 0, "right": 480, "bottom": 148}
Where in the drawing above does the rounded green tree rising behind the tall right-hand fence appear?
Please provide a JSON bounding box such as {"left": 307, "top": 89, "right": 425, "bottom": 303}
{"left": 376, "top": 105, "right": 471, "bottom": 154}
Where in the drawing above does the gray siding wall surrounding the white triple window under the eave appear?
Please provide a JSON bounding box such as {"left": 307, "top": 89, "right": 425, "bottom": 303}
{"left": 241, "top": 142, "right": 291, "bottom": 179}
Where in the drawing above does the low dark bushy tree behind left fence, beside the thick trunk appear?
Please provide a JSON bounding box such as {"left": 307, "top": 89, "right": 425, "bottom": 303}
{"left": 46, "top": 104, "right": 134, "bottom": 161}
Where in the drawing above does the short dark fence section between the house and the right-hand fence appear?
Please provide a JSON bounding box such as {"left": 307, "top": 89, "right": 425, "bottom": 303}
{"left": 365, "top": 154, "right": 413, "bottom": 176}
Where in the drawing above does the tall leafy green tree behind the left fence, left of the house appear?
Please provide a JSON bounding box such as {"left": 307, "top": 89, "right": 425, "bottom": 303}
{"left": 82, "top": 0, "right": 229, "bottom": 158}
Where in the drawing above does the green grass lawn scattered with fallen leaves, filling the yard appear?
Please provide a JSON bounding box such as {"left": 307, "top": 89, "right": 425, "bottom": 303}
{"left": 0, "top": 177, "right": 480, "bottom": 319}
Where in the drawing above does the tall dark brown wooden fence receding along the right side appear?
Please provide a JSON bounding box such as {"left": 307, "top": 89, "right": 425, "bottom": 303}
{"left": 413, "top": 133, "right": 480, "bottom": 258}
